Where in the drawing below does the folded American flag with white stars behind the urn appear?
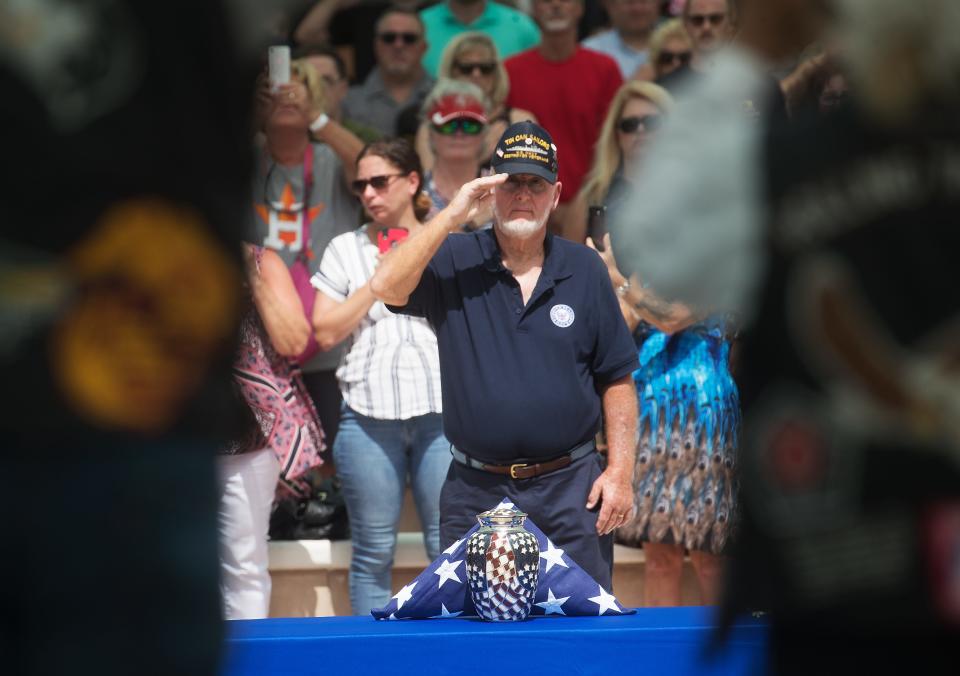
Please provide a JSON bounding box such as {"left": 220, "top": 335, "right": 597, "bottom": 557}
{"left": 370, "top": 499, "right": 636, "bottom": 620}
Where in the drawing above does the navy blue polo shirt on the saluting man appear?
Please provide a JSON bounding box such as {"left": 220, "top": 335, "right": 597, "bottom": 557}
{"left": 390, "top": 229, "right": 638, "bottom": 463}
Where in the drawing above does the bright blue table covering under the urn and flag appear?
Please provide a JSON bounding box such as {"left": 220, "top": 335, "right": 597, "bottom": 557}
{"left": 224, "top": 608, "right": 766, "bottom": 676}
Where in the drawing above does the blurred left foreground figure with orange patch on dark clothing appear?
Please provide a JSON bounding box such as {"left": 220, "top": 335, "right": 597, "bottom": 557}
{"left": 0, "top": 0, "right": 252, "bottom": 676}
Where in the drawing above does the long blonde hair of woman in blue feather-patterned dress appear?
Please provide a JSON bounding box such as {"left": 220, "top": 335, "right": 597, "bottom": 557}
{"left": 580, "top": 80, "right": 673, "bottom": 205}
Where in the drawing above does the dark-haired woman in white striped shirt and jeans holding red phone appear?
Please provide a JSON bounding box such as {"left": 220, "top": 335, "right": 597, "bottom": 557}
{"left": 312, "top": 139, "right": 450, "bottom": 614}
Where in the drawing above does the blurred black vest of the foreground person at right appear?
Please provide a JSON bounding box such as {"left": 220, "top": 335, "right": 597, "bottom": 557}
{"left": 722, "top": 101, "right": 960, "bottom": 674}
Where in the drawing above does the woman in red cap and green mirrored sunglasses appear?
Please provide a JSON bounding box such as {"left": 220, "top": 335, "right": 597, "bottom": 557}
{"left": 423, "top": 79, "right": 490, "bottom": 230}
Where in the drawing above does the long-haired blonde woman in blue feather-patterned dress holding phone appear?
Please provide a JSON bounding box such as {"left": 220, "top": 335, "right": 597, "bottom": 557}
{"left": 581, "top": 81, "right": 740, "bottom": 606}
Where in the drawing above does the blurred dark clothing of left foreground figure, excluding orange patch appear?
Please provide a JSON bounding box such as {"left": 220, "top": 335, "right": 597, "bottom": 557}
{"left": 0, "top": 0, "right": 256, "bottom": 676}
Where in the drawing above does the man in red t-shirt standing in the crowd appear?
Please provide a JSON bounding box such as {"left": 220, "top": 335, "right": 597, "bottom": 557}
{"left": 505, "top": 0, "right": 623, "bottom": 234}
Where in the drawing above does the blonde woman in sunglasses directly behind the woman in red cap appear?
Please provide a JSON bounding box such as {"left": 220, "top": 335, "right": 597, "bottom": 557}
{"left": 417, "top": 32, "right": 537, "bottom": 172}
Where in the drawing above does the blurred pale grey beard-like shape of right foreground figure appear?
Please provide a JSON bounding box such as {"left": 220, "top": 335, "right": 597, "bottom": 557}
{"left": 610, "top": 0, "right": 827, "bottom": 319}
